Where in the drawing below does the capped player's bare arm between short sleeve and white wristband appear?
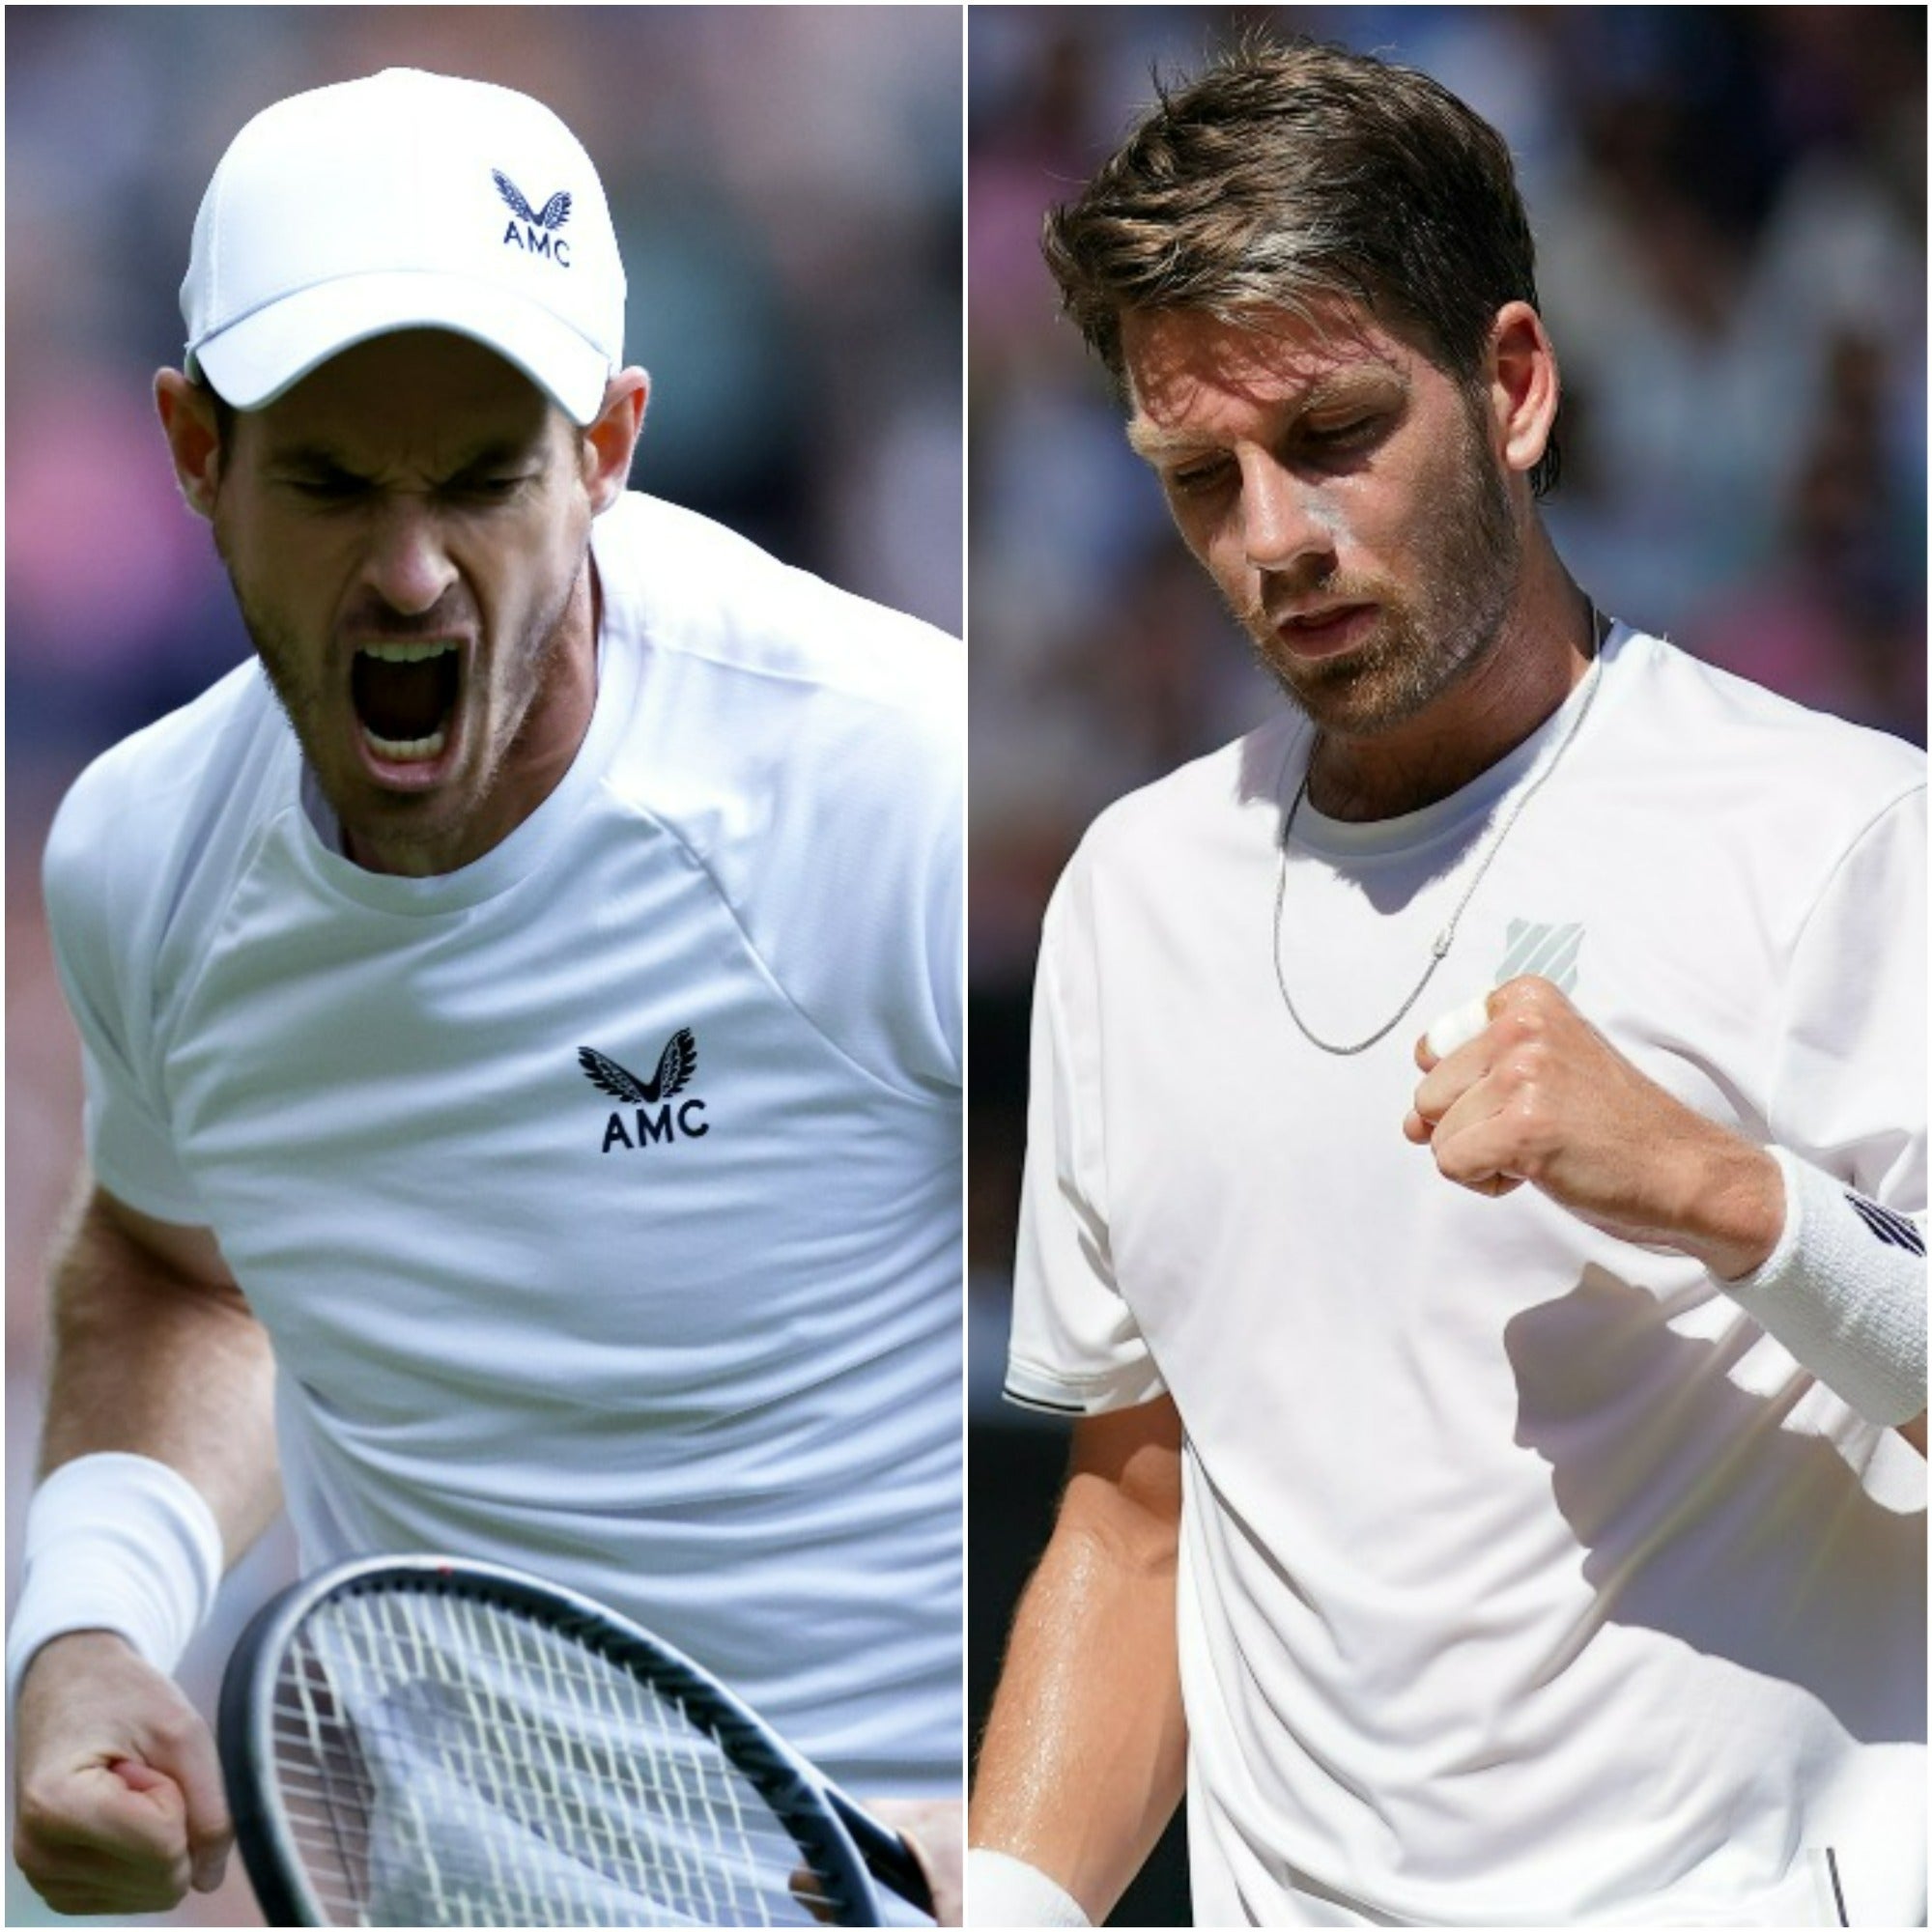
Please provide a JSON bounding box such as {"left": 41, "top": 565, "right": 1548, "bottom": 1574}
{"left": 41, "top": 1194, "right": 280, "bottom": 1561}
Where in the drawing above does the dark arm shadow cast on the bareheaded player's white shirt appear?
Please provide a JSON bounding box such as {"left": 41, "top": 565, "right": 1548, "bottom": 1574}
{"left": 1505, "top": 1267, "right": 1926, "bottom": 1745}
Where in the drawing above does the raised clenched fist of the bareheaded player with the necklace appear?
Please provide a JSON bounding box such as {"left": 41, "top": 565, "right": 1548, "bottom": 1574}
{"left": 1403, "top": 976, "right": 1785, "bottom": 1281}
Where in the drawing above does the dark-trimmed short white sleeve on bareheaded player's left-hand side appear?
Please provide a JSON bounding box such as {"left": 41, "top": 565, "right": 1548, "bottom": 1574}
{"left": 1007, "top": 856, "right": 1165, "bottom": 1414}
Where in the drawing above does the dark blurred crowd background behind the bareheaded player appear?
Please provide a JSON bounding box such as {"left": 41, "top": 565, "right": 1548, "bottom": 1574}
{"left": 968, "top": 6, "right": 1926, "bottom": 1924}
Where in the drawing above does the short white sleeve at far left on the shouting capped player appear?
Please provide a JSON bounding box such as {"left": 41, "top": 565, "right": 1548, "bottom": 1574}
{"left": 43, "top": 767, "right": 207, "bottom": 1227}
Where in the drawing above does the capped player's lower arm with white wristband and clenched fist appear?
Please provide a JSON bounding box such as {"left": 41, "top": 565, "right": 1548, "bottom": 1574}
{"left": 8, "top": 1192, "right": 276, "bottom": 1917}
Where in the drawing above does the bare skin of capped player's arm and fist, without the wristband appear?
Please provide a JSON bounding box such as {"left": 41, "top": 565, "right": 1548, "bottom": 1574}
{"left": 14, "top": 1188, "right": 278, "bottom": 1915}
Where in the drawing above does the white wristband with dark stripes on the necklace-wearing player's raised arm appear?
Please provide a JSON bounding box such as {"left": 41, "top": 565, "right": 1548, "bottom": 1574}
{"left": 1723, "top": 1148, "right": 1926, "bottom": 1428}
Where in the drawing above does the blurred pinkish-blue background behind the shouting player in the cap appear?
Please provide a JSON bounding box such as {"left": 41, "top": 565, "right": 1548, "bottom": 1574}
{"left": 6, "top": 6, "right": 962, "bottom": 1926}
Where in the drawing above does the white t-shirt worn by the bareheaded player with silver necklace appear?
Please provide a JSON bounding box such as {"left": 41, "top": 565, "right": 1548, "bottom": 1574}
{"left": 1009, "top": 630, "right": 1926, "bottom": 1926}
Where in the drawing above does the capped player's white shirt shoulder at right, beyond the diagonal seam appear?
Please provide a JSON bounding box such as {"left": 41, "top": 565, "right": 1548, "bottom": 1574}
{"left": 580, "top": 497, "right": 966, "bottom": 1097}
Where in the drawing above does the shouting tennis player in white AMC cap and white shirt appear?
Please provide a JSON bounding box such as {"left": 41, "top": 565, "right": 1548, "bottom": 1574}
{"left": 8, "top": 71, "right": 962, "bottom": 1915}
